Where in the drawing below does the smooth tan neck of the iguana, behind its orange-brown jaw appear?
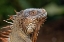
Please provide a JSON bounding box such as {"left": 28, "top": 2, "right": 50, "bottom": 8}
{"left": 10, "top": 18, "right": 32, "bottom": 42}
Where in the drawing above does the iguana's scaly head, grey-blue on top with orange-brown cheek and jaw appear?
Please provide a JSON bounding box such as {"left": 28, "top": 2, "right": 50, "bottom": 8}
{"left": 20, "top": 8, "right": 47, "bottom": 33}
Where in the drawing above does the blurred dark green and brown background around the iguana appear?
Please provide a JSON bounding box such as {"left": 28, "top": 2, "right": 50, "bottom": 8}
{"left": 0, "top": 0, "right": 64, "bottom": 42}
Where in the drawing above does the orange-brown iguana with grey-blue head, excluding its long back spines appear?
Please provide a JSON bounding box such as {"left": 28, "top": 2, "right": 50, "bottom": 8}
{"left": 0, "top": 8, "right": 47, "bottom": 42}
